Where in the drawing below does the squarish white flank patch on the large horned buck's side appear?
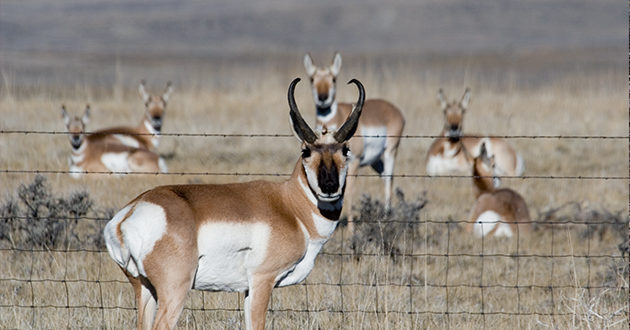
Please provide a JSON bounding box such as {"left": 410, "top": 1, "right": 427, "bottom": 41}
{"left": 194, "top": 222, "right": 271, "bottom": 291}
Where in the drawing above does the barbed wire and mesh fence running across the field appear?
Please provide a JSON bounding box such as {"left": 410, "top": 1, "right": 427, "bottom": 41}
{"left": 0, "top": 130, "right": 630, "bottom": 328}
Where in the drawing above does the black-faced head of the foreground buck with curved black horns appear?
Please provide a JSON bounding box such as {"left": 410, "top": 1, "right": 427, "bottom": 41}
{"left": 288, "top": 78, "right": 365, "bottom": 203}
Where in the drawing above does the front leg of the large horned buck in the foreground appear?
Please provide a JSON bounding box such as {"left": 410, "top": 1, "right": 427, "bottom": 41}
{"left": 244, "top": 274, "right": 276, "bottom": 330}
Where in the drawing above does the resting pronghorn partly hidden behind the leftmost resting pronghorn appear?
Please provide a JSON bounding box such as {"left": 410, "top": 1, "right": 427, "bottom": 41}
{"left": 94, "top": 80, "right": 173, "bottom": 151}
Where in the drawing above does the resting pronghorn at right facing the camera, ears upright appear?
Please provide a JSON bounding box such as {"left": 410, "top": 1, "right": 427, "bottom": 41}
{"left": 426, "top": 88, "right": 524, "bottom": 176}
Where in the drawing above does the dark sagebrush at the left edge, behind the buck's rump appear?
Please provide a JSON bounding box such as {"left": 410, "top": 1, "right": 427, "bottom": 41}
{"left": 0, "top": 175, "right": 111, "bottom": 249}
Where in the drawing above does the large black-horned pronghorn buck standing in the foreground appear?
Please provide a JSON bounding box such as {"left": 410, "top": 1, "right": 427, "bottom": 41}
{"left": 104, "top": 78, "right": 365, "bottom": 329}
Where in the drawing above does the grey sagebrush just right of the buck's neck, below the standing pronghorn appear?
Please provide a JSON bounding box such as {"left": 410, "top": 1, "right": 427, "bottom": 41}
{"left": 352, "top": 189, "right": 427, "bottom": 258}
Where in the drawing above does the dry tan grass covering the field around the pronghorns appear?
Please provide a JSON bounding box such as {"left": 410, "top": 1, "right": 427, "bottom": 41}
{"left": 0, "top": 53, "right": 628, "bottom": 329}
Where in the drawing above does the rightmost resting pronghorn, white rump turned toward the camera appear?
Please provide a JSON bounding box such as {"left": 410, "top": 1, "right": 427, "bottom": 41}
{"left": 467, "top": 143, "right": 531, "bottom": 237}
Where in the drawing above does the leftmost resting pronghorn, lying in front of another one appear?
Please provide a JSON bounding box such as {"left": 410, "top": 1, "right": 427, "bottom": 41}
{"left": 61, "top": 105, "right": 167, "bottom": 179}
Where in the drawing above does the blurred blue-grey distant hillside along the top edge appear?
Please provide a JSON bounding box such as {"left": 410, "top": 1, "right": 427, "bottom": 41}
{"left": 0, "top": 0, "right": 628, "bottom": 55}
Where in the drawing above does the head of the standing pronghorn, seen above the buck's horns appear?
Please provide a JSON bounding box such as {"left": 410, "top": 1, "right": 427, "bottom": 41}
{"left": 304, "top": 53, "right": 341, "bottom": 109}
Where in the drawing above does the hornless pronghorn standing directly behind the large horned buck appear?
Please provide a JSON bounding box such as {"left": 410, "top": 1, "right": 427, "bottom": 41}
{"left": 304, "top": 53, "right": 405, "bottom": 231}
